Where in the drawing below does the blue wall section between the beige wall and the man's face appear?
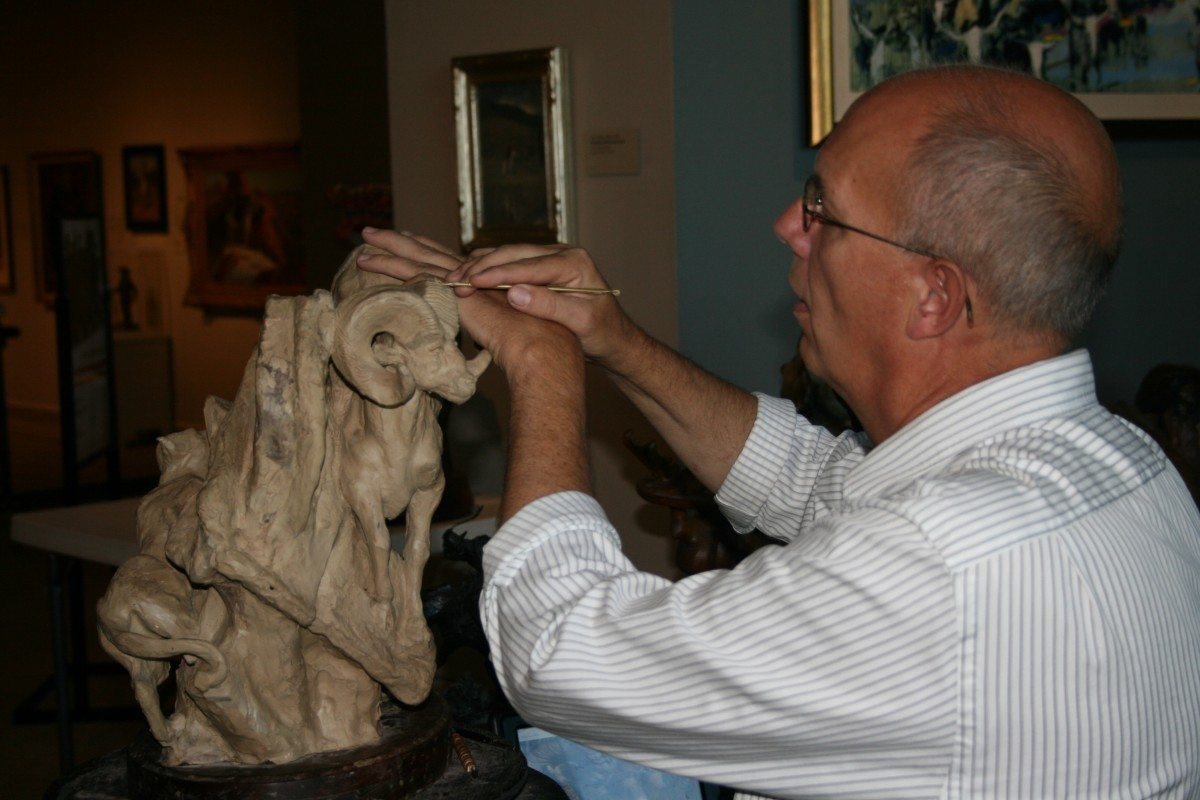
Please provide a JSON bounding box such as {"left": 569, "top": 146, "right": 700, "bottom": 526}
{"left": 672, "top": 0, "right": 815, "bottom": 391}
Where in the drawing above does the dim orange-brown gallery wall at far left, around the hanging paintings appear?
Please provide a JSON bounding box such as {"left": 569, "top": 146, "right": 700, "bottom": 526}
{"left": 0, "top": 0, "right": 299, "bottom": 425}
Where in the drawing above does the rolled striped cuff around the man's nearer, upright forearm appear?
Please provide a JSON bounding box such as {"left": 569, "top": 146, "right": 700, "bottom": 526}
{"left": 484, "top": 492, "right": 620, "bottom": 583}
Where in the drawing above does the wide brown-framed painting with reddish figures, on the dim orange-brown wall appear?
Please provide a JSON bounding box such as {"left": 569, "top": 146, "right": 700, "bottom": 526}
{"left": 180, "top": 144, "right": 308, "bottom": 311}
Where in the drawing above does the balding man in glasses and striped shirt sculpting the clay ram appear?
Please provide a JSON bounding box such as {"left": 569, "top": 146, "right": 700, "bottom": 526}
{"left": 362, "top": 67, "right": 1200, "bottom": 798}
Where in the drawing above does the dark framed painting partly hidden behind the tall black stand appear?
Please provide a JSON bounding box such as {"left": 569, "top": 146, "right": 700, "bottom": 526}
{"left": 29, "top": 151, "right": 104, "bottom": 306}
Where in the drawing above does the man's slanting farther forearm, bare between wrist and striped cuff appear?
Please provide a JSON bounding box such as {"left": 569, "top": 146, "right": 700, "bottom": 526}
{"left": 600, "top": 321, "right": 758, "bottom": 492}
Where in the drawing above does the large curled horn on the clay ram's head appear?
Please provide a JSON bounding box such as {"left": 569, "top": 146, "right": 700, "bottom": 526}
{"left": 332, "top": 284, "right": 442, "bottom": 408}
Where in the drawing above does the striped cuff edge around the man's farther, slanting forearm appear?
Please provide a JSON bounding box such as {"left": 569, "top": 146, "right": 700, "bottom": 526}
{"left": 716, "top": 392, "right": 797, "bottom": 534}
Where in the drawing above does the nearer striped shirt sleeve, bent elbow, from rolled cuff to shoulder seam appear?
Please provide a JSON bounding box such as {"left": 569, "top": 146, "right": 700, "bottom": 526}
{"left": 480, "top": 493, "right": 956, "bottom": 798}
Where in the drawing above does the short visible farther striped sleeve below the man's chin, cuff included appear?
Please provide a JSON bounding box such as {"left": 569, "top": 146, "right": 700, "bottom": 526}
{"left": 716, "top": 393, "right": 868, "bottom": 541}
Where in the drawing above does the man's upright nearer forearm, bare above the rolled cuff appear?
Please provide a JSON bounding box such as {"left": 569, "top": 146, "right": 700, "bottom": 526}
{"left": 499, "top": 340, "right": 592, "bottom": 523}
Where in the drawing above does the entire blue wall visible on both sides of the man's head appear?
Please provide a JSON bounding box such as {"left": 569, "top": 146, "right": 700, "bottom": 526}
{"left": 673, "top": 0, "right": 1200, "bottom": 407}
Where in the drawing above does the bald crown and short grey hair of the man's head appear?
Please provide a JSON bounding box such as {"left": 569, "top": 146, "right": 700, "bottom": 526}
{"left": 847, "top": 66, "right": 1121, "bottom": 341}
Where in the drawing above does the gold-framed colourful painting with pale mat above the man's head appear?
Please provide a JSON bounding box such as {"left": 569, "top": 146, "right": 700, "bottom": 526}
{"left": 808, "top": 0, "right": 1200, "bottom": 145}
